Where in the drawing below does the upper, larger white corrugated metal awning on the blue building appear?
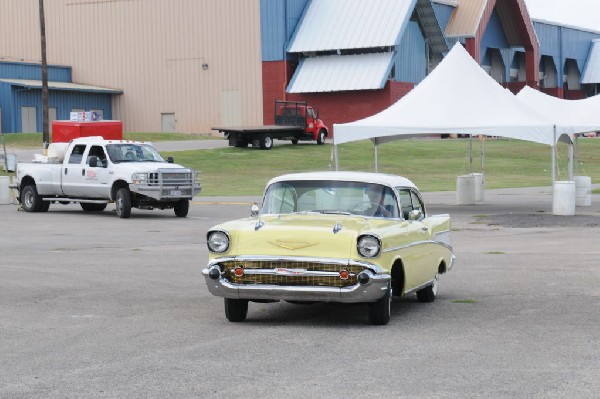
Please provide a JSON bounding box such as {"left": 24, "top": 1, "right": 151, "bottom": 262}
{"left": 288, "top": 0, "right": 416, "bottom": 53}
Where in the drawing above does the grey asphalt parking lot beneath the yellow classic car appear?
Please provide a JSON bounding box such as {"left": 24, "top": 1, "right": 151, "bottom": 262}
{"left": 0, "top": 188, "right": 600, "bottom": 398}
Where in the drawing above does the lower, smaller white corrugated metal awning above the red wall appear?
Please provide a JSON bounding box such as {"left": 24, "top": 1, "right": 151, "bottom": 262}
{"left": 287, "top": 53, "right": 393, "bottom": 93}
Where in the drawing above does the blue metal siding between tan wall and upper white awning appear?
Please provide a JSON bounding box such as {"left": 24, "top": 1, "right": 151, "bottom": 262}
{"left": 260, "top": 0, "right": 308, "bottom": 61}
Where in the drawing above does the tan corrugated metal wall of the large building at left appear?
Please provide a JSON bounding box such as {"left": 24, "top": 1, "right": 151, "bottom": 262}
{"left": 0, "top": 0, "right": 262, "bottom": 133}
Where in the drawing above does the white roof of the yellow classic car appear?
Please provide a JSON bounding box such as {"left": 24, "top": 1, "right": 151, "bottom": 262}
{"left": 267, "top": 171, "right": 417, "bottom": 189}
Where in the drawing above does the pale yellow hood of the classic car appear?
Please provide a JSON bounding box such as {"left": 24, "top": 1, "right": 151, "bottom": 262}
{"left": 213, "top": 214, "right": 390, "bottom": 258}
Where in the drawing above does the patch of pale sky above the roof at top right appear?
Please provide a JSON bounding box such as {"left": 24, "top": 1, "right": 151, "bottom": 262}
{"left": 525, "top": 0, "right": 600, "bottom": 32}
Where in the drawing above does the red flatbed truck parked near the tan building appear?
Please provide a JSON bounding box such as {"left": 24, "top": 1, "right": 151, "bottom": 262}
{"left": 212, "top": 100, "right": 329, "bottom": 150}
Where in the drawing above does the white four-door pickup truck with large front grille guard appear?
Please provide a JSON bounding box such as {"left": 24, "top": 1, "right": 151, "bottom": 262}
{"left": 13, "top": 137, "right": 200, "bottom": 218}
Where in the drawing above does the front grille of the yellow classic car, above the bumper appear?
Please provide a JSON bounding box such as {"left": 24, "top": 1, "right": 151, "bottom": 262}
{"left": 220, "top": 260, "right": 364, "bottom": 287}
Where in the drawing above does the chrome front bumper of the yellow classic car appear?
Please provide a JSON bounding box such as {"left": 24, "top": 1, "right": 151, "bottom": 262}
{"left": 202, "top": 262, "right": 391, "bottom": 303}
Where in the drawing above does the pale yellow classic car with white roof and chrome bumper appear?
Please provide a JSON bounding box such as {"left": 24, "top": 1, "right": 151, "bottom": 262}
{"left": 202, "top": 172, "right": 455, "bottom": 325}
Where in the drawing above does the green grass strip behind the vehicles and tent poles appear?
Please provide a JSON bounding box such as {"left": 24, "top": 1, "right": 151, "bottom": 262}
{"left": 0, "top": 133, "right": 600, "bottom": 196}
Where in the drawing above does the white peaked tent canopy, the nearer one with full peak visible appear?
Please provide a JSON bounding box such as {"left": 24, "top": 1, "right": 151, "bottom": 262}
{"left": 333, "top": 43, "right": 556, "bottom": 146}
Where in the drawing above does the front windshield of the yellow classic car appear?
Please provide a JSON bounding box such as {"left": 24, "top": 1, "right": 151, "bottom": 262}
{"left": 260, "top": 180, "right": 399, "bottom": 218}
